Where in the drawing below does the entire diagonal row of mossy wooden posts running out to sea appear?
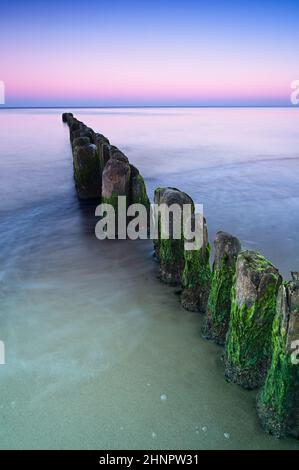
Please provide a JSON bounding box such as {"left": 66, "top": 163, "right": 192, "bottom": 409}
{"left": 62, "top": 113, "right": 299, "bottom": 438}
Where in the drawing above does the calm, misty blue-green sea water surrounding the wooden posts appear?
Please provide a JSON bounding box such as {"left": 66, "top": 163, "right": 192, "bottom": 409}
{"left": 0, "top": 109, "right": 299, "bottom": 449}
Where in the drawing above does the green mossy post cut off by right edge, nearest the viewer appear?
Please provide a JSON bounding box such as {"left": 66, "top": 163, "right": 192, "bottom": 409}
{"left": 257, "top": 274, "right": 299, "bottom": 438}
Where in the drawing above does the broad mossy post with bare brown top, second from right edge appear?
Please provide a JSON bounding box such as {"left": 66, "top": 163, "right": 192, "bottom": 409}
{"left": 225, "top": 251, "right": 282, "bottom": 389}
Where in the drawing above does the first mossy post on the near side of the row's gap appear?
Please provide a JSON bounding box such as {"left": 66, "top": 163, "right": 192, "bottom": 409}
{"left": 154, "top": 188, "right": 194, "bottom": 285}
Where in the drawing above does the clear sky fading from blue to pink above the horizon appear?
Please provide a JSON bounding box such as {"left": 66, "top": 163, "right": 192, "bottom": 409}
{"left": 0, "top": 0, "right": 299, "bottom": 107}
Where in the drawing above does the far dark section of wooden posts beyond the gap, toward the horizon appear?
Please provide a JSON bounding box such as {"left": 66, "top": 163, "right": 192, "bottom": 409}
{"left": 62, "top": 113, "right": 149, "bottom": 209}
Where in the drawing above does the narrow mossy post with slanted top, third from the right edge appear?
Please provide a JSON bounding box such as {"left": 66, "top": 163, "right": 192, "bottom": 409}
{"left": 202, "top": 232, "right": 241, "bottom": 345}
